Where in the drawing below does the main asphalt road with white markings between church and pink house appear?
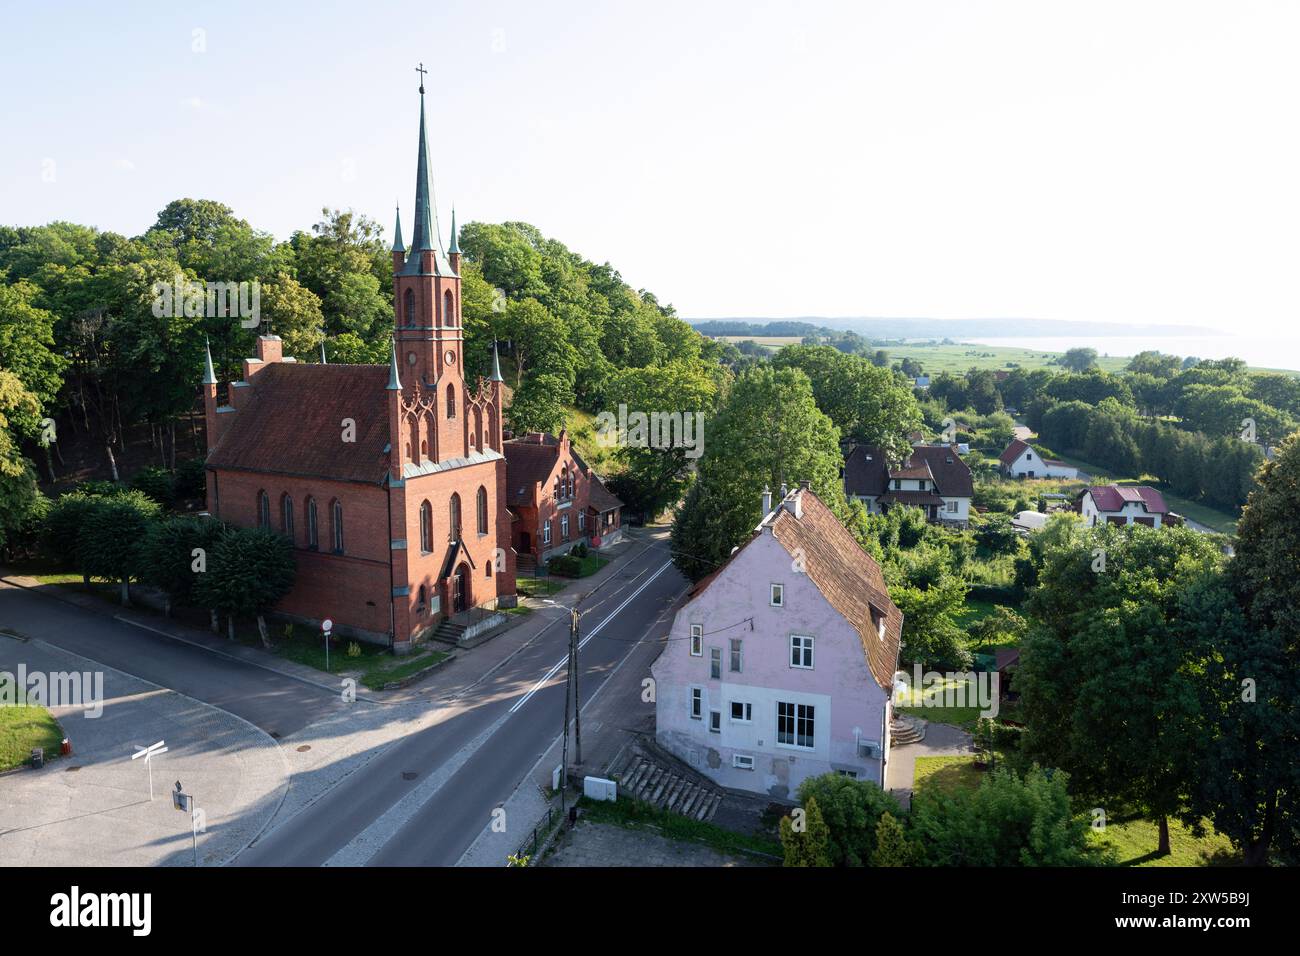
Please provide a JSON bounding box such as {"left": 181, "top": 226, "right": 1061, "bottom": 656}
{"left": 235, "top": 546, "right": 685, "bottom": 866}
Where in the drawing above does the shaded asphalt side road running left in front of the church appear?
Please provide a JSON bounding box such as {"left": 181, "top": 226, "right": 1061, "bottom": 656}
{"left": 0, "top": 583, "right": 347, "bottom": 736}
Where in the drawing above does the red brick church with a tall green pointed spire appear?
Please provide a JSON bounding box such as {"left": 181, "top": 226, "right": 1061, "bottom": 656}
{"left": 203, "top": 87, "right": 515, "bottom": 653}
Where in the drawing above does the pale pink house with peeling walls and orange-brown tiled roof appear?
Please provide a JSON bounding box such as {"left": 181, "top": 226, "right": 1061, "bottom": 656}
{"left": 651, "top": 483, "right": 902, "bottom": 797}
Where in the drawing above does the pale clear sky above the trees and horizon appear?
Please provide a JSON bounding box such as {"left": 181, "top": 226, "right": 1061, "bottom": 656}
{"left": 0, "top": 0, "right": 1300, "bottom": 336}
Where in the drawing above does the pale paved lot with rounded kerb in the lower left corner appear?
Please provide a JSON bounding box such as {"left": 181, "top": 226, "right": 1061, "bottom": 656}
{"left": 0, "top": 636, "right": 289, "bottom": 866}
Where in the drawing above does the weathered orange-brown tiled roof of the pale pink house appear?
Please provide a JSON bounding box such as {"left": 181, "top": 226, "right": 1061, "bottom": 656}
{"left": 771, "top": 490, "right": 902, "bottom": 689}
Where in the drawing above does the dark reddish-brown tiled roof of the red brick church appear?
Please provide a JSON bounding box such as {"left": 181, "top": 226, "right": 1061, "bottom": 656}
{"left": 208, "top": 362, "right": 389, "bottom": 484}
